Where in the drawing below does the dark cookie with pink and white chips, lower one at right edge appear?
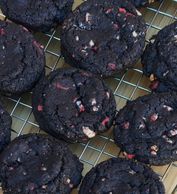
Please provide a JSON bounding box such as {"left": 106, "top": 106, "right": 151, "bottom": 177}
{"left": 114, "top": 92, "right": 177, "bottom": 165}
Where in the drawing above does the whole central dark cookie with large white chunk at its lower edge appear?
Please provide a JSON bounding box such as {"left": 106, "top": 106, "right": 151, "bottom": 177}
{"left": 32, "top": 68, "right": 116, "bottom": 142}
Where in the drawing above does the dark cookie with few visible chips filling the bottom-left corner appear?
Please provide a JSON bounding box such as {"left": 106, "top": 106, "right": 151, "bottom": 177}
{"left": 0, "top": 134, "right": 83, "bottom": 194}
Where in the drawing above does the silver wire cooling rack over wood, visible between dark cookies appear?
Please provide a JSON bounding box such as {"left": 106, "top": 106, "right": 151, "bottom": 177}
{"left": 0, "top": 0, "right": 177, "bottom": 194}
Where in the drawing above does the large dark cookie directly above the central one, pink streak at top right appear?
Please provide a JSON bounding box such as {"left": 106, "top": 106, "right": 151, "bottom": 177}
{"left": 61, "top": 0, "right": 146, "bottom": 76}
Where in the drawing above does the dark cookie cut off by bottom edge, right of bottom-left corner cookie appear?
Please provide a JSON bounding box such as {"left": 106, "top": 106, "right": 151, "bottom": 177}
{"left": 79, "top": 158, "right": 165, "bottom": 194}
